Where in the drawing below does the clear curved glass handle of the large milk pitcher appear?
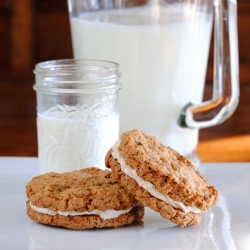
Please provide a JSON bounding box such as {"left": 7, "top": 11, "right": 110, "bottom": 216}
{"left": 178, "top": 0, "right": 239, "bottom": 128}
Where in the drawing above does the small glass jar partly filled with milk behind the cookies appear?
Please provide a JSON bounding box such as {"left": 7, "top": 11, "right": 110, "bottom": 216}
{"left": 34, "top": 59, "right": 121, "bottom": 174}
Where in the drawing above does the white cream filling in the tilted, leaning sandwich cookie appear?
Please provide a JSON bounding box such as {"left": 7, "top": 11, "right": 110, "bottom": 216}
{"left": 112, "top": 140, "right": 202, "bottom": 214}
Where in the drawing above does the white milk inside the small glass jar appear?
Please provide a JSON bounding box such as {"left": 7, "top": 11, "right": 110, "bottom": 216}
{"left": 37, "top": 106, "right": 119, "bottom": 174}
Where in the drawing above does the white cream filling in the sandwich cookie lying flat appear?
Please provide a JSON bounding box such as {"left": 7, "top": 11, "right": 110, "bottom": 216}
{"left": 30, "top": 202, "right": 133, "bottom": 220}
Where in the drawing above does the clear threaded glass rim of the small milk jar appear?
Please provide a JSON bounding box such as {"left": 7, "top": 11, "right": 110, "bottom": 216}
{"left": 33, "top": 59, "right": 121, "bottom": 93}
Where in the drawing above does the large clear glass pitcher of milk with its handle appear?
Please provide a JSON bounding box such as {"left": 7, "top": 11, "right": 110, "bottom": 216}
{"left": 68, "top": 0, "right": 239, "bottom": 162}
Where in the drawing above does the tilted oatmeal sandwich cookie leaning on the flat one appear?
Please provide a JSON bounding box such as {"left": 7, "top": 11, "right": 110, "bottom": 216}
{"left": 105, "top": 130, "right": 219, "bottom": 227}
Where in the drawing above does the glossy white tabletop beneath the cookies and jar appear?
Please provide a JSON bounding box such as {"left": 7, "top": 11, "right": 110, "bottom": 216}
{"left": 0, "top": 157, "right": 250, "bottom": 250}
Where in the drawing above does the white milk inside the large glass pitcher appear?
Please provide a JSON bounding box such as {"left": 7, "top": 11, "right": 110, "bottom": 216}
{"left": 71, "top": 5, "right": 212, "bottom": 158}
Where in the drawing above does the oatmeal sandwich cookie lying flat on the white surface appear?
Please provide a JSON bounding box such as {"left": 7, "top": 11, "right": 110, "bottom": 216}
{"left": 26, "top": 167, "right": 144, "bottom": 229}
